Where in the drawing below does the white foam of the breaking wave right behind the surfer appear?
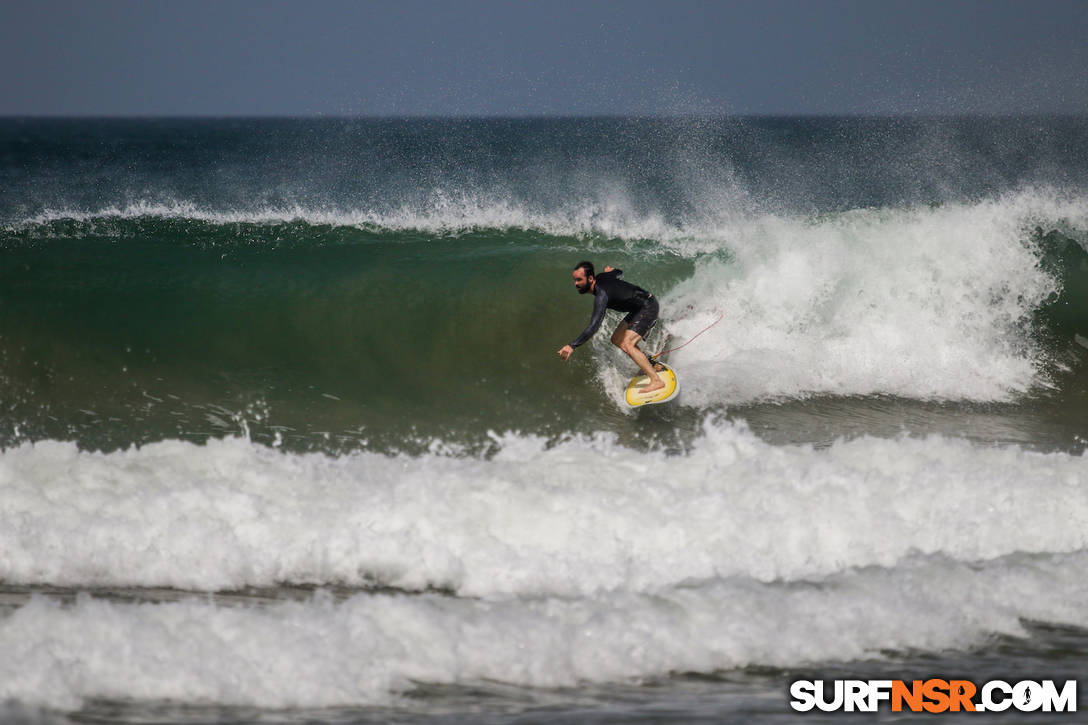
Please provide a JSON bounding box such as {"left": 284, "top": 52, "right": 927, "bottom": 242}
{"left": 663, "top": 189, "right": 1088, "bottom": 406}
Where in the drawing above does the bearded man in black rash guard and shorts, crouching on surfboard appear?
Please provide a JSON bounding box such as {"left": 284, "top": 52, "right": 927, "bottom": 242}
{"left": 559, "top": 261, "right": 665, "bottom": 393}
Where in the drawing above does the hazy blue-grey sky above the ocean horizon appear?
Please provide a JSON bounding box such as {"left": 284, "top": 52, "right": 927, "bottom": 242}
{"left": 0, "top": 0, "right": 1088, "bottom": 115}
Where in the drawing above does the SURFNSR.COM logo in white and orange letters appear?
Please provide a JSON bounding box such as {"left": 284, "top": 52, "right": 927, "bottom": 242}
{"left": 790, "top": 678, "right": 1077, "bottom": 713}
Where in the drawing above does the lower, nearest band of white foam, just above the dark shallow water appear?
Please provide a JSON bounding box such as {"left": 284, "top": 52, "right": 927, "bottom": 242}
{"left": 0, "top": 552, "right": 1088, "bottom": 709}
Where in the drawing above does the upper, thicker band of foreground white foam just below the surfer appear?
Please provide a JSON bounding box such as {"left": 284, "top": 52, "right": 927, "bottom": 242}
{"left": 0, "top": 423, "right": 1088, "bottom": 597}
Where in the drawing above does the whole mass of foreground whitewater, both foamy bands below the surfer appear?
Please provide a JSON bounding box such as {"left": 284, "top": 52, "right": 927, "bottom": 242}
{"left": 6, "top": 423, "right": 1088, "bottom": 708}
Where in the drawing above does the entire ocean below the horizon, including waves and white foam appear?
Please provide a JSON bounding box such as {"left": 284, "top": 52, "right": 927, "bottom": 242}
{"left": 0, "top": 118, "right": 1088, "bottom": 724}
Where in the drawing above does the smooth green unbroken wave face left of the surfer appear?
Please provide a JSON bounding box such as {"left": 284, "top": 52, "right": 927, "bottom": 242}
{"left": 0, "top": 218, "right": 691, "bottom": 450}
